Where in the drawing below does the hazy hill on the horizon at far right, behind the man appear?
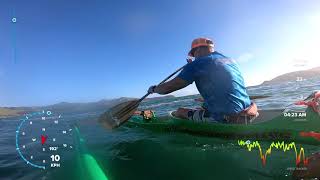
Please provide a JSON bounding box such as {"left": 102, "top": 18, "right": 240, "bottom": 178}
{"left": 261, "top": 67, "right": 320, "bottom": 85}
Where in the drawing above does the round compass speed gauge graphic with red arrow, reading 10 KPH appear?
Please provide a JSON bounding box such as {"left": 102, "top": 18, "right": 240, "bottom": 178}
{"left": 16, "top": 110, "right": 74, "bottom": 169}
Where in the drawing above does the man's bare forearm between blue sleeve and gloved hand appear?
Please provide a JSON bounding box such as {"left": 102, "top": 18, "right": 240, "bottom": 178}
{"left": 154, "top": 77, "right": 189, "bottom": 95}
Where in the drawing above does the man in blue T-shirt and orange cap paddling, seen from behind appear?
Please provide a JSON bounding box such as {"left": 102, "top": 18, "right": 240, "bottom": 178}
{"left": 148, "top": 38, "right": 258, "bottom": 123}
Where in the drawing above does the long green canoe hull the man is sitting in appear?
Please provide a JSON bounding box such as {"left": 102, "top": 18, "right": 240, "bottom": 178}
{"left": 127, "top": 107, "right": 320, "bottom": 144}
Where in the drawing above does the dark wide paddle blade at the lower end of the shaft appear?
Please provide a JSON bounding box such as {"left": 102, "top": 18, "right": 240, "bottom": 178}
{"left": 98, "top": 100, "right": 139, "bottom": 129}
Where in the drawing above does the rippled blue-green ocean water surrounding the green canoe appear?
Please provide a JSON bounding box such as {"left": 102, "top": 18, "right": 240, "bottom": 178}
{"left": 0, "top": 79, "right": 320, "bottom": 180}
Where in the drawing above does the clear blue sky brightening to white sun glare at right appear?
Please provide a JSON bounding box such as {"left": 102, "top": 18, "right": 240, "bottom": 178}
{"left": 0, "top": 0, "right": 320, "bottom": 106}
